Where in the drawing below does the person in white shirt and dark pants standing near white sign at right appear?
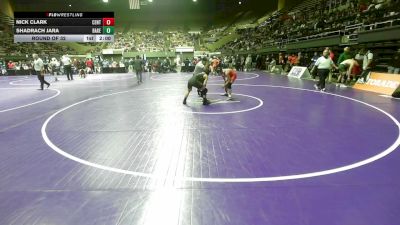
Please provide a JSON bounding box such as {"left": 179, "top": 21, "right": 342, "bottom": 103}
{"left": 313, "top": 49, "right": 337, "bottom": 91}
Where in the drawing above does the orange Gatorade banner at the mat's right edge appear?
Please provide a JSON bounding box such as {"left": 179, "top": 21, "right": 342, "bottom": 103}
{"left": 353, "top": 72, "right": 400, "bottom": 95}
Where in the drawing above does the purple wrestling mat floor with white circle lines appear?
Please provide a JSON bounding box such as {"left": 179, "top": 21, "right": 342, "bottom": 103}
{"left": 0, "top": 72, "right": 400, "bottom": 225}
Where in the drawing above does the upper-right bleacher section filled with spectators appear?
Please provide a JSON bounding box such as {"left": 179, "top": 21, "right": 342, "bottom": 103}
{"left": 220, "top": 0, "right": 400, "bottom": 52}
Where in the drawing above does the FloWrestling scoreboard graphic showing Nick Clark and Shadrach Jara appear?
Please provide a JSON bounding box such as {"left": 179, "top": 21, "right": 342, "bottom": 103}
{"left": 14, "top": 12, "right": 115, "bottom": 43}
